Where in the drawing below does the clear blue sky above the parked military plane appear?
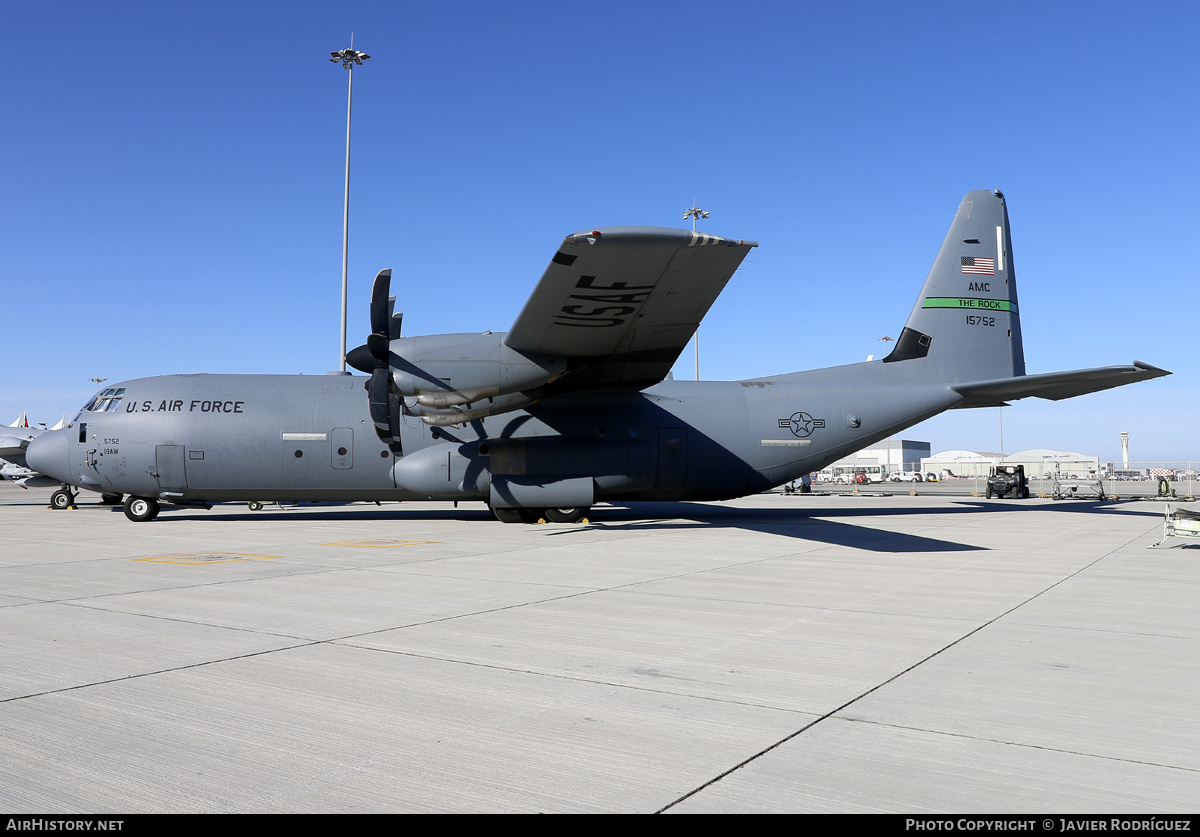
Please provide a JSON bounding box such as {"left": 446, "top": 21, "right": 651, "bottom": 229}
{"left": 0, "top": 1, "right": 1200, "bottom": 460}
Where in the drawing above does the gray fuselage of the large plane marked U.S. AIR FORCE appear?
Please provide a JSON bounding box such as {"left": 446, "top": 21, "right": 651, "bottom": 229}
{"left": 30, "top": 361, "right": 961, "bottom": 505}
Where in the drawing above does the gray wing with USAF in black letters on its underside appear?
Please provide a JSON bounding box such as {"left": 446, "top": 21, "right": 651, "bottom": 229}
{"left": 504, "top": 227, "right": 758, "bottom": 389}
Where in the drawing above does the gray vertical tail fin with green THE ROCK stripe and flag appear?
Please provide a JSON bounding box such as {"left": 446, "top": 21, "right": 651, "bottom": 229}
{"left": 883, "top": 189, "right": 1025, "bottom": 384}
